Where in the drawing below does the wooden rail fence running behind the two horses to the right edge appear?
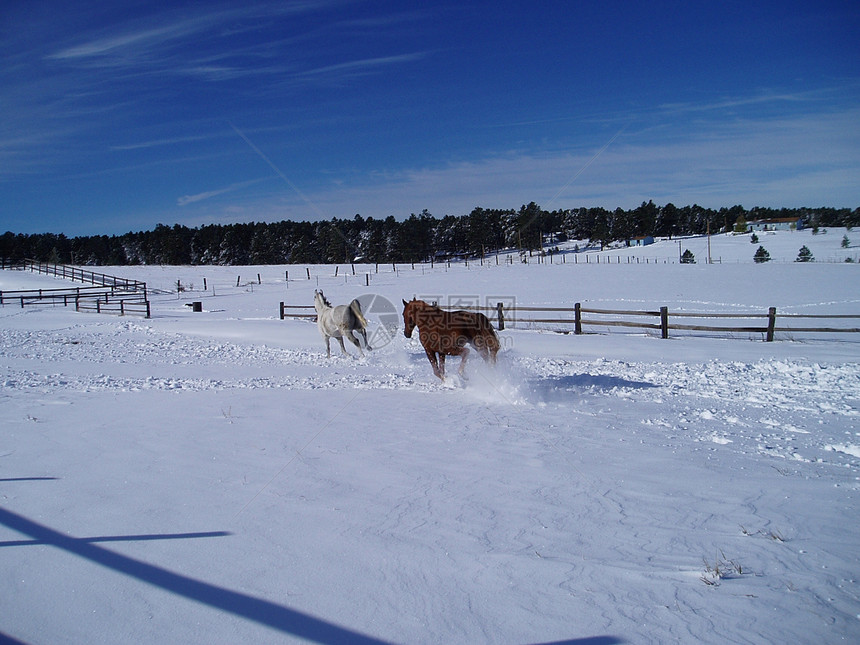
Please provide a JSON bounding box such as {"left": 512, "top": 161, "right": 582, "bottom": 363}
{"left": 279, "top": 302, "right": 860, "bottom": 342}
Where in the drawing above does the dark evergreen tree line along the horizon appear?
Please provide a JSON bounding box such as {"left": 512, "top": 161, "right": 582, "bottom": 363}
{"left": 0, "top": 201, "right": 860, "bottom": 266}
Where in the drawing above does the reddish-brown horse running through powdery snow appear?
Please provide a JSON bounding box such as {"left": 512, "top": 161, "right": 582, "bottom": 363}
{"left": 403, "top": 298, "right": 500, "bottom": 381}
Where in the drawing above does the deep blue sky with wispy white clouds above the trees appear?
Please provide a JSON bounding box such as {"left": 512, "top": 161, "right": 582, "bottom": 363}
{"left": 0, "top": 0, "right": 860, "bottom": 236}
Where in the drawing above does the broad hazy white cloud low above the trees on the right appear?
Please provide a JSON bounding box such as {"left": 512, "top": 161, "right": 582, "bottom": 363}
{"left": 249, "top": 109, "right": 860, "bottom": 219}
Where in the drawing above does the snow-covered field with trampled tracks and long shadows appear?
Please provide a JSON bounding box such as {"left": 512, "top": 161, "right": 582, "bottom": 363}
{"left": 0, "top": 230, "right": 860, "bottom": 644}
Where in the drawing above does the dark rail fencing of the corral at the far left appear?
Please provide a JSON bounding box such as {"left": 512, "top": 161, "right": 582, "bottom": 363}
{"left": 0, "top": 260, "right": 151, "bottom": 318}
